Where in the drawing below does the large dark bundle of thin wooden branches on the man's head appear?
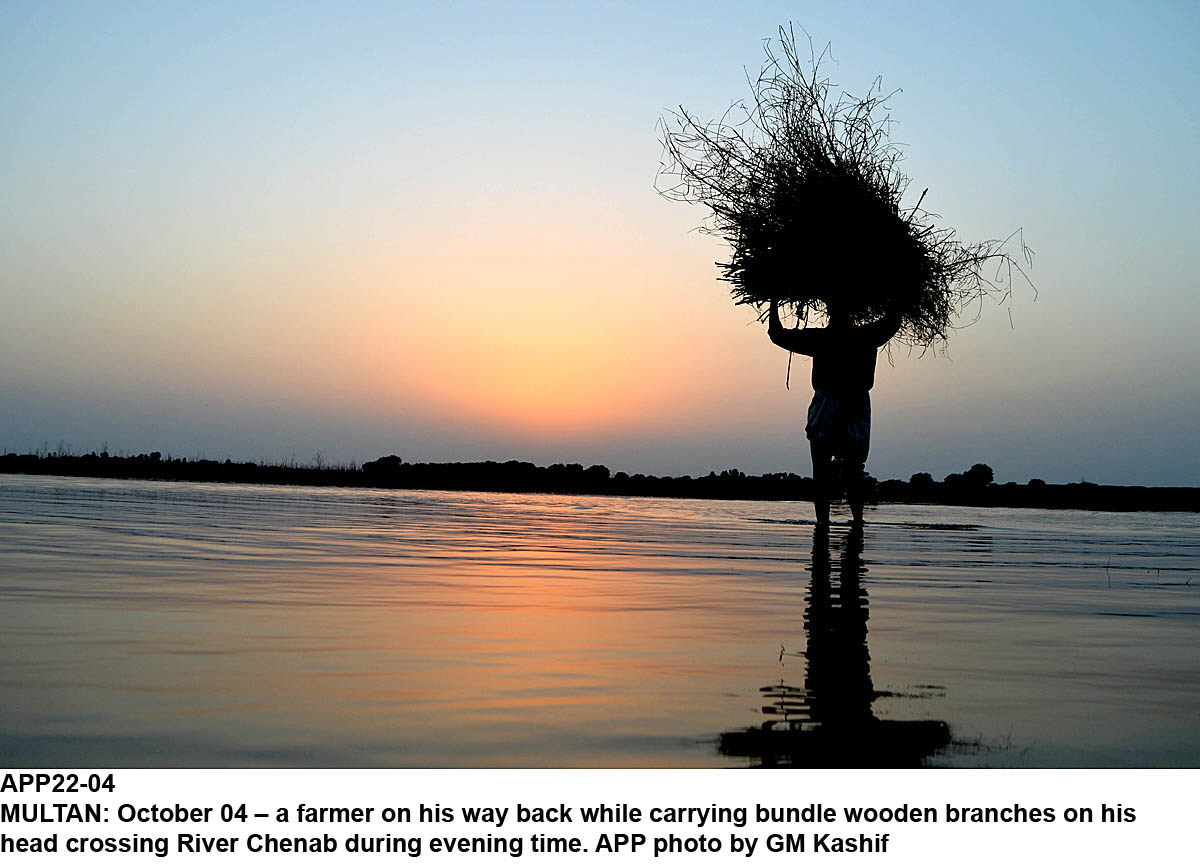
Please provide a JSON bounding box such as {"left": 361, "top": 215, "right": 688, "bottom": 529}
{"left": 660, "top": 28, "right": 1031, "bottom": 346}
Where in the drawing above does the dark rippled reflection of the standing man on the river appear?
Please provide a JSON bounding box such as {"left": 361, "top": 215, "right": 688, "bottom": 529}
{"left": 720, "top": 527, "right": 950, "bottom": 768}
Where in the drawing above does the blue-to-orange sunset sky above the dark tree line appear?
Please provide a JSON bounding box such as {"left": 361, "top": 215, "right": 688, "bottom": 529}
{"left": 0, "top": 0, "right": 1200, "bottom": 485}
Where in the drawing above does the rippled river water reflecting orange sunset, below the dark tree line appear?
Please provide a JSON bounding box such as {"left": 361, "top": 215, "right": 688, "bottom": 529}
{"left": 0, "top": 475, "right": 1200, "bottom": 767}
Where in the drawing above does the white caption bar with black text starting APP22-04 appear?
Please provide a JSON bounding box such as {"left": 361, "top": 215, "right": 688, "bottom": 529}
{"left": 0, "top": 769, "right": 1196, "bottom": 864}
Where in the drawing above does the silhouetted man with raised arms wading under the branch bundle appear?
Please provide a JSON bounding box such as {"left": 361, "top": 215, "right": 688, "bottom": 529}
{"left": 767, "top": 300, "right": 900, "bottom": 524}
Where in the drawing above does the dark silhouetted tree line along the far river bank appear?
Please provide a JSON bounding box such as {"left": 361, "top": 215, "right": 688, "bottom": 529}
{"left": 0, "top": 448, "right": 1200, "bottom": 512}
